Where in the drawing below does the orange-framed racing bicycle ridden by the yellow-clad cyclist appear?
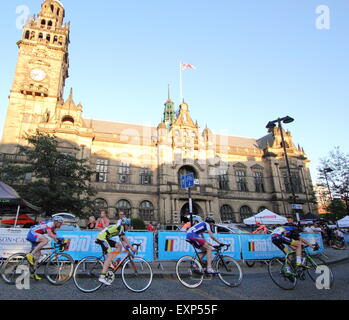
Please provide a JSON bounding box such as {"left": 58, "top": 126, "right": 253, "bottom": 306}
{"left": 73, "top": 243, "right": 153, "bottom": 293}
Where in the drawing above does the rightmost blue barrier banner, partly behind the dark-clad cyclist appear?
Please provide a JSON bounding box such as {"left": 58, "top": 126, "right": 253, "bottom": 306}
{"left": 240, "top": 233, "right": 324, "bottom": 260}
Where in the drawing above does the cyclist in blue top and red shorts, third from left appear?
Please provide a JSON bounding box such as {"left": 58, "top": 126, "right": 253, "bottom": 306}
{"left": 187, "top": 218, "right": 224, "bottom": 274}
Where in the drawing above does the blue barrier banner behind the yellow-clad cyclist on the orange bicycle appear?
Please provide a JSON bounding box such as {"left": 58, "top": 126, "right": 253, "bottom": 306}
{"left": 57, "top": 231, "right": 154, "bottom": 262}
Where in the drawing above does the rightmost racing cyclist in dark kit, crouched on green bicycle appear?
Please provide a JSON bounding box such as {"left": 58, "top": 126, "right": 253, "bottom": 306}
{"left": 272, "top": 222, "right": 319, "bottom": 267}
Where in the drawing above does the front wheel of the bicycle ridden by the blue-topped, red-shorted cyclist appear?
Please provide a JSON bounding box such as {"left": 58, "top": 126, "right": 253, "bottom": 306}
{"left": 214, "top": 256, "right": 243, "bottom": 287}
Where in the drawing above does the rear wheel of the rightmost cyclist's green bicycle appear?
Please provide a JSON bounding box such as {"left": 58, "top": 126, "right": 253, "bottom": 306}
{"left": 268, "top": 258, "right": 297, "bottom": 290}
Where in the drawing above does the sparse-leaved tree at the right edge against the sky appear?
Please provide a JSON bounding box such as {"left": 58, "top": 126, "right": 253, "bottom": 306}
{"left": 318, "top": 147, "right": 349, "bottom": 214}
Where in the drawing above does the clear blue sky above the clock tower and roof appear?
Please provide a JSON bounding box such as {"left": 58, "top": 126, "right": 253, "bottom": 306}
{"left": 0, "top": 0, "right": 349, "bottom": 180}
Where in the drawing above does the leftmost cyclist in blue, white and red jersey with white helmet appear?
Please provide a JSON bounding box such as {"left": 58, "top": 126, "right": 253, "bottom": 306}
{"left": 25, "top": 217, "right": 64, "bottom": 280}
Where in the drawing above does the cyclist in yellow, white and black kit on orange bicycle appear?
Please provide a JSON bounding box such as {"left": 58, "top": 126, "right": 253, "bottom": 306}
{"left": 96, "top": 218, "right": 137, "bottom": 286}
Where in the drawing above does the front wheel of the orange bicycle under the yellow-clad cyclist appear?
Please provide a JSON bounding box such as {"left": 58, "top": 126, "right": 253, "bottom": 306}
{"left": 121, "top": 257, "right": 153, "bottom": 292}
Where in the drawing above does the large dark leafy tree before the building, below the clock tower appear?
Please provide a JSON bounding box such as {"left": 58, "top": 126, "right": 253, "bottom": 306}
{"left": 0, "top": 133, "right": 96, "bottom": 217}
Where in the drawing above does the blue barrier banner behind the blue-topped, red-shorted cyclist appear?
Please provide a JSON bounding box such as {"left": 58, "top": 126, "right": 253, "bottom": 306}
{"left": 158, "top": 232, "right": 241, "bottom": 261}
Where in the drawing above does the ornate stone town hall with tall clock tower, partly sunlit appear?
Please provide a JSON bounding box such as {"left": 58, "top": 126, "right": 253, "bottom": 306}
{"left": 0, "top": 0, "right": 314, "bottom": 223}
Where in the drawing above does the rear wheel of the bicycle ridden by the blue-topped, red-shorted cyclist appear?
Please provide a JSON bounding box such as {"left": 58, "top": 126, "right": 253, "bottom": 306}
{"left": 176, "top": 256, "right": 204, "bottom": 289}
